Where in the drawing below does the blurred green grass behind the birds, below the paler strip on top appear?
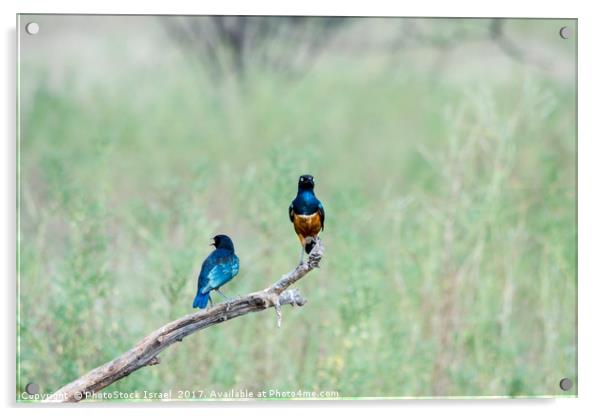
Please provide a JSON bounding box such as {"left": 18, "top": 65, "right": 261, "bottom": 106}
{"left": 17, "top": 17, "right": 576, "bottom": 397}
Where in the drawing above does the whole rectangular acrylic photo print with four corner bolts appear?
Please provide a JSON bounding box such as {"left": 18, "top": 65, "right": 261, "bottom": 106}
{"left": 16, "top": 15, "right": 577, "bottom": 402}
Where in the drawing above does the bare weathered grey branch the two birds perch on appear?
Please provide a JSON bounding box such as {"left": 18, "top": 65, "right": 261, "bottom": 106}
{"left": 47, "top": 240, "right": 324, "bottom": 402}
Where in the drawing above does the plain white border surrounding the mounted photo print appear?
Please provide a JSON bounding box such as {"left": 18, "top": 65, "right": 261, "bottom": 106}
{"left": 0, "top": 0, "right": 602, "bottom": 416}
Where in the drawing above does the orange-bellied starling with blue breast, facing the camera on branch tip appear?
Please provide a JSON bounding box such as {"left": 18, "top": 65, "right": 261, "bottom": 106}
{"left": 288, "top": 175, "right": 326, "bottom": 264}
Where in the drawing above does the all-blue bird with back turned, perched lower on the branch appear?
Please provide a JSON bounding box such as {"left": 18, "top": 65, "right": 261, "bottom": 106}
{"left": 192, "top": 235, "right": 239, "bottom": 309}
